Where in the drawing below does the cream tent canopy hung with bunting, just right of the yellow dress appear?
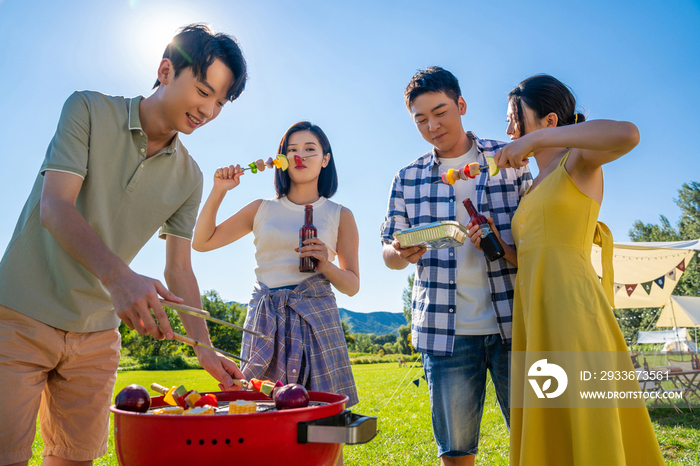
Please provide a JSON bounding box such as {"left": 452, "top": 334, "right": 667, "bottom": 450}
{"left": 591, "top": 239, "right": 700, "bottom": 310}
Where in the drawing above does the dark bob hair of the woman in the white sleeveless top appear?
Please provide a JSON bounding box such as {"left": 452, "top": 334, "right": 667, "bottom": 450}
{"left": 275, "top": 121, "right": 338, "bottom": 198}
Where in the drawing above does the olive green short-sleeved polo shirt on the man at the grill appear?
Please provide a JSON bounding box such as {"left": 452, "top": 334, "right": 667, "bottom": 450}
{"left": 0, "top": 91, "right": 203, "bottom": 332}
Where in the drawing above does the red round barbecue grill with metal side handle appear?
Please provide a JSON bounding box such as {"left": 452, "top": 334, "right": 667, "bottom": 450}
{"left": 111, "top": 391, "right": 377, "bottom": 466}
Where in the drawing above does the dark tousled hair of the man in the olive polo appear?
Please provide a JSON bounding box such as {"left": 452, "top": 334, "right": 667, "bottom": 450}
{"left": 153, "top": 23, "right": 248, "bottom": 102}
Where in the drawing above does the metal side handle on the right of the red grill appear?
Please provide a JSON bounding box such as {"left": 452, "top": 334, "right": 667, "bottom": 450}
{"left": 297, "top": 409, "right": 377, "bottom": 445}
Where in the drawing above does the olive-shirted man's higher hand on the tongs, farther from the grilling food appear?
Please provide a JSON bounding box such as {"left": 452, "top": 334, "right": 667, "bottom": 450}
{"left": 107, "top": 268, "right": 182, "bottom": 340}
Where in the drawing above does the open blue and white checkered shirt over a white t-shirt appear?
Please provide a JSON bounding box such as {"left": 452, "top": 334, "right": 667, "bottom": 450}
{"left": 381, "top": 132, "right": 532, "bottom": 356}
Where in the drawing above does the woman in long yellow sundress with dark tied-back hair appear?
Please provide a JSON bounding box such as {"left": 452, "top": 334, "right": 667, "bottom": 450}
{"left": 472, "top": 75, "right": 664, "bottom": 466}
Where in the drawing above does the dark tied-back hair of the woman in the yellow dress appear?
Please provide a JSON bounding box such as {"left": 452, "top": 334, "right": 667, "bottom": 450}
{"left": 508, "top": 74, "right": 586, "bottom": 136}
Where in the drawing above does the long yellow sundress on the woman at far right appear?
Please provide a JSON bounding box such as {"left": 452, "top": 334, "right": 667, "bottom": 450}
{"left": 510, "top": 151, "right": 665, "bottom": 466}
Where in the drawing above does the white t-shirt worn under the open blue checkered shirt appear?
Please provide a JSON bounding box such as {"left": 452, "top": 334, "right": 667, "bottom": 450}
{"left": 438, "top": 141, "right": 498, "bottom": 335}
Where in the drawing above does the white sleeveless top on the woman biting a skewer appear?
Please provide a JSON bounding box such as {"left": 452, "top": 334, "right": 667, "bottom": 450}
{"left": 253, "top": 197, "right": 342, "bottom": 288}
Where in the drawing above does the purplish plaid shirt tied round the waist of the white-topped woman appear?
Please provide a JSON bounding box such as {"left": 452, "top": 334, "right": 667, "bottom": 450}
{"left": 241, "top": 274, "right": 359, "bottom": 407}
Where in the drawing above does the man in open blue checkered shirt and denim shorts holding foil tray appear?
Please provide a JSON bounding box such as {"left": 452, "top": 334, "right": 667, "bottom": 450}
{"left": 381, "top": 67, "right": 532, "bottom": 465}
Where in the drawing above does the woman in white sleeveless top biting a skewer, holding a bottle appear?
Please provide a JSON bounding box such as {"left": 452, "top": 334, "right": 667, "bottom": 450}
{"left": 192, "top": 121, "right": 360, "bottom": 406}
